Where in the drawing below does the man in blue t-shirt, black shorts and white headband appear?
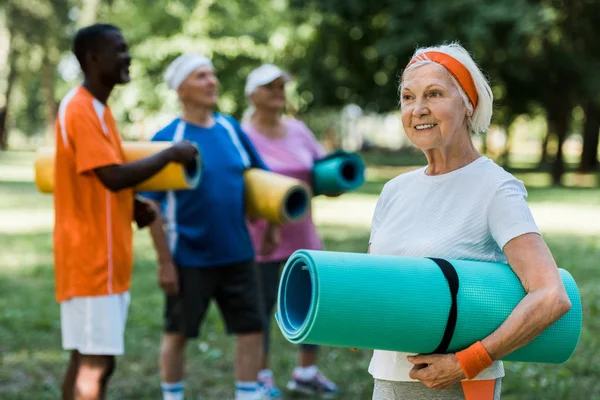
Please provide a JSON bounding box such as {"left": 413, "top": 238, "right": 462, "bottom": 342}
{"left": 144, "top": 54, "right": 276, "bottom": 400}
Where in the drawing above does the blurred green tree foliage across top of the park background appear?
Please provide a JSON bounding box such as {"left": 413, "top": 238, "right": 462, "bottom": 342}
{"left": 0, "top": 0, "right": 600, "bottom": 183}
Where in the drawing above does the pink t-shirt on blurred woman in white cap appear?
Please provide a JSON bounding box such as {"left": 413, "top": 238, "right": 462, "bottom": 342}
{"left": 242, "top": 118, "right": 325, "bottom": 262}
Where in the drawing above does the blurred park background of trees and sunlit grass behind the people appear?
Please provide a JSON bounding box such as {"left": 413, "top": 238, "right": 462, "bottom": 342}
{"left": 0, "top": 0, "right": 600, "bottom": 400}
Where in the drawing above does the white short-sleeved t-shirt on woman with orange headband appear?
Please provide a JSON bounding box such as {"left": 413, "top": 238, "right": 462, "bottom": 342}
{"left": 369, "top": 157, "right": 539, "bottom": 381}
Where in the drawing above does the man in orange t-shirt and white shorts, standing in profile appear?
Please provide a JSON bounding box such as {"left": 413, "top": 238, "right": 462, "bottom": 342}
{"left": 53, "top": 24, "right": 197, "bottom": 399}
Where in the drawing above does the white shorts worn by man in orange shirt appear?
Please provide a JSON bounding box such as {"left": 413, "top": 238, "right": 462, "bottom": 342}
{"left": 60, "top": 292, "right": 129, "bottom": 356}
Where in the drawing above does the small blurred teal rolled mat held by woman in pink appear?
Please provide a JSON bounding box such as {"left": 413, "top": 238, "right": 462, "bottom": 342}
{"left": 312, "top": 150, "right": 365, "bottom": 196}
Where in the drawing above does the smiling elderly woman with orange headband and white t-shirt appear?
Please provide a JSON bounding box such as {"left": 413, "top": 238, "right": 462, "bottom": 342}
{"left": 369, "top": 44, "right": 571, "bottom": 400}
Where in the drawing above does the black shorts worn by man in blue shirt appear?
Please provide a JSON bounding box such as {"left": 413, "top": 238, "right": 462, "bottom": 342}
{"left": 165, "top": 261, "right": 263, "bottom": 338}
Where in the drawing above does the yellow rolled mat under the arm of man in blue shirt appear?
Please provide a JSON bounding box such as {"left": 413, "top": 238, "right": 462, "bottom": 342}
{"left": 244, "top": 168, "right": 311, "bottom": 225}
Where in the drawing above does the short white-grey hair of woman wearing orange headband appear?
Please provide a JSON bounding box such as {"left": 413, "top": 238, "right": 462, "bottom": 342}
{"left": 398, "top": 43, "right": 494, "bottom": 133}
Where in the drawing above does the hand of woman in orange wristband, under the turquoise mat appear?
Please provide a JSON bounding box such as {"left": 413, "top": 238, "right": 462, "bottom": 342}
{"left": 407, "top": 354, "right": 465, "bottom": 390}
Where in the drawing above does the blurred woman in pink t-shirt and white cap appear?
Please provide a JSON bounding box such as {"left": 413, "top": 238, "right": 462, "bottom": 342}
{"left": 243, "top": 64, "right": 338, "bottom": 398}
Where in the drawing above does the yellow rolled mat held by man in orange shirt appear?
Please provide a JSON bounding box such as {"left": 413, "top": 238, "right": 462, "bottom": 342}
{"left": 34, "top": 142, "right": 202, "bottom": 193}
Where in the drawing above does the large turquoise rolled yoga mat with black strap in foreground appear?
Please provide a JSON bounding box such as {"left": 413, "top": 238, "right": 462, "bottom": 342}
{"left": 276, "top": 250, "right": 582, "bottom": 363}
